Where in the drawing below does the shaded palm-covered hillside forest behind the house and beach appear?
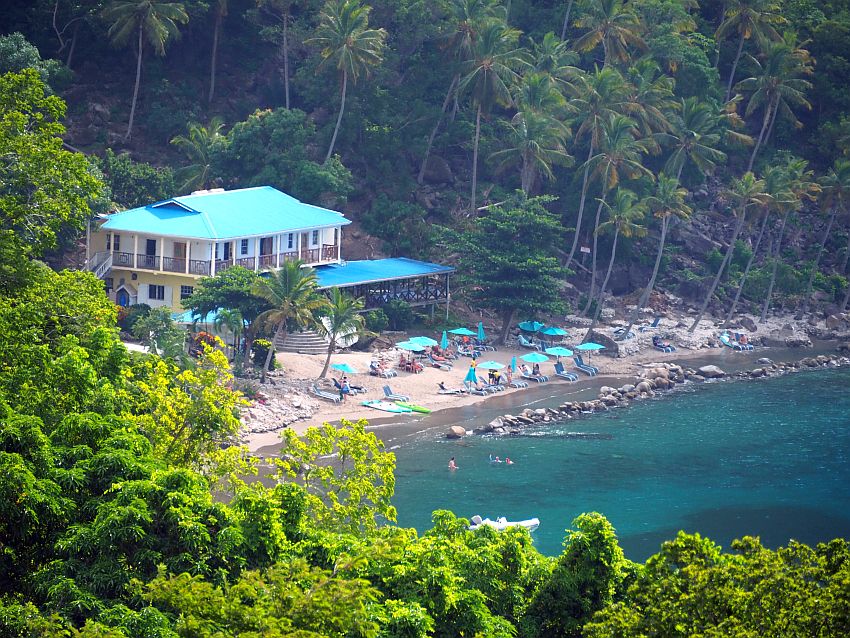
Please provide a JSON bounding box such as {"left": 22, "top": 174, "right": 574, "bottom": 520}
{"left": 0, "top": 0, "right": 850, "bottom": 330}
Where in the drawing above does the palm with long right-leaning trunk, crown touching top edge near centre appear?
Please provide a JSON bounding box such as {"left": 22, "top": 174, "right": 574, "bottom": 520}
{"left": 416, "top": 0, "right": 504, "bottom": 184}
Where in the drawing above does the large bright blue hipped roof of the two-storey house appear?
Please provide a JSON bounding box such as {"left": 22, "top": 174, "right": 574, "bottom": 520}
{"left": 101, "top": 186, "right": 351, "bottom": 240}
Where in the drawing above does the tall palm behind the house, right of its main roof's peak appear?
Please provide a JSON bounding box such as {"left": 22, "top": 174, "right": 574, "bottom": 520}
{"left": 307, "top": 0, "right": 387, "bottom": 162}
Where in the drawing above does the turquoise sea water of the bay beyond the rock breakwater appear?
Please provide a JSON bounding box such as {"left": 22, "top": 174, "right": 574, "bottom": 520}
{"left": 394, "top": 370, "right": 850, "bottom": 560}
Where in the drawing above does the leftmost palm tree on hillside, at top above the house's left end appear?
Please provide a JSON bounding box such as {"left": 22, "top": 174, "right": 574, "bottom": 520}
{"left": 101, "top": 0, "right": 189, "bottom": 139}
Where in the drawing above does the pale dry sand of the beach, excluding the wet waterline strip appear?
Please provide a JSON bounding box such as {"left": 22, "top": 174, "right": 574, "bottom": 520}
{"left": 246, "top": 315, "right": 824, "bottom": 451}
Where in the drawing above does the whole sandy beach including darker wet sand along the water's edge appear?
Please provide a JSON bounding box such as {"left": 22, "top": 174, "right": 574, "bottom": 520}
{"left": 240, "top": 318, "right": 835, "bottom": 453}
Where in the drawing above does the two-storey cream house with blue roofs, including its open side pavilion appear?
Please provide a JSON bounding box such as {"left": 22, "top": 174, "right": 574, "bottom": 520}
{"left": 86, "top": 186, "right": 454, "bottom": 310}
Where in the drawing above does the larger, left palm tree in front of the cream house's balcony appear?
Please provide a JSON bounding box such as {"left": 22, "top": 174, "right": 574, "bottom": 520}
{"left": 254, "top": 260, "right": 328, "bottom": 383}
